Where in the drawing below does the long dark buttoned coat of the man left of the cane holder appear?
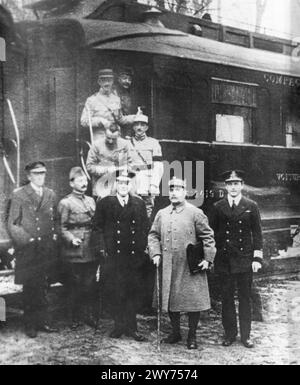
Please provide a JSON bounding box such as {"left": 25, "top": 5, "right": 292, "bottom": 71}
{"left": 93, "top": 196, "right": 148, "bottom": 299}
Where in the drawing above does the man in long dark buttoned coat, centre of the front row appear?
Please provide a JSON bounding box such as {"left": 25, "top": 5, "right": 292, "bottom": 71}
{"left": 94, "top": 171, "right": 148, "bottom": 341}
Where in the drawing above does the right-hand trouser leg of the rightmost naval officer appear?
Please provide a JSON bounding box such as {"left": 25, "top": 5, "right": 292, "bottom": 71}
{"left": 237, "top": 273, "right": 252, "bottom": 341}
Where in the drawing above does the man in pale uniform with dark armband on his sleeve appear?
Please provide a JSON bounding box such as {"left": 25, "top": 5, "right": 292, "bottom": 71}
{"left": 130, "top": 113, "right": 164, "bottom": 219}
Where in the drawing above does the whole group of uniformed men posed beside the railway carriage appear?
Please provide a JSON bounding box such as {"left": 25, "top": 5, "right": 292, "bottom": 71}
{"left": 8, "top": 69, "right": 262, "bottom": 349}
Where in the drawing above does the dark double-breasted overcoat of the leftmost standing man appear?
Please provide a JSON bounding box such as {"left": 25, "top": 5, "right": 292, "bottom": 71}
{"left": 8, "top": 184, "right": 58, "bottom": 285}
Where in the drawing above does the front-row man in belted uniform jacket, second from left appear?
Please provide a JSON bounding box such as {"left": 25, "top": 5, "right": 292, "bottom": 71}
{"left": 58, "top": 167, "right": 97, "bottom": 329}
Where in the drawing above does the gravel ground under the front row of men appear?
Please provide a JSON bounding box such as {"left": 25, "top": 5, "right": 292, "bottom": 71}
{"left": 0, "top": 280, "right": 300, "bottom": 365}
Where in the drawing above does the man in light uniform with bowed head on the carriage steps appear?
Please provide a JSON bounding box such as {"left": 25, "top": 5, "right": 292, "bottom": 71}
{"left": 86, "top": 123, "right": 132, "bottom": 198}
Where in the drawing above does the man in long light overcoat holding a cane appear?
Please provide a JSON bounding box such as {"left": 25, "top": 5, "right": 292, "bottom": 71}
{"left": 148, "top": 178, "right": 215, "bottom": 349}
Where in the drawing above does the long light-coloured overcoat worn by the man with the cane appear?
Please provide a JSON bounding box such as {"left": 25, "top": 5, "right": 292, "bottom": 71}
{"left": 148, "top": 201, "right": 216, "bottom": 312}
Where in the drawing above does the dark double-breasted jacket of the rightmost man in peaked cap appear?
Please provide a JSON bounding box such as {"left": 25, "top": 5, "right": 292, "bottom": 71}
{"left": 210, "top": 197, "right": 263, "bottom": 274}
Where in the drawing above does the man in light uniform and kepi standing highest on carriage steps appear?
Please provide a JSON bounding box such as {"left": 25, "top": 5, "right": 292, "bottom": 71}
{"left": 81, "top": 69, "right": 133, "bottom": 140}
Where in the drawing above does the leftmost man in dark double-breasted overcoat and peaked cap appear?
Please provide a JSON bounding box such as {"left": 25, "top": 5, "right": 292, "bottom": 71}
{"left": 8, "top": 162, "right": 57, "bottom": 338}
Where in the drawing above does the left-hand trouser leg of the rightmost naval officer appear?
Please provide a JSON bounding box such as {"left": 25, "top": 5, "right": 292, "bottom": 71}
{"left": 220, "top": 274, "right": 237, "bottom": 339}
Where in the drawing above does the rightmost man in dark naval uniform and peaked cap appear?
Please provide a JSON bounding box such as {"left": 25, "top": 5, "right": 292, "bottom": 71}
{"left": 211, "top": 170, "right": 263, "bottom": 348}
